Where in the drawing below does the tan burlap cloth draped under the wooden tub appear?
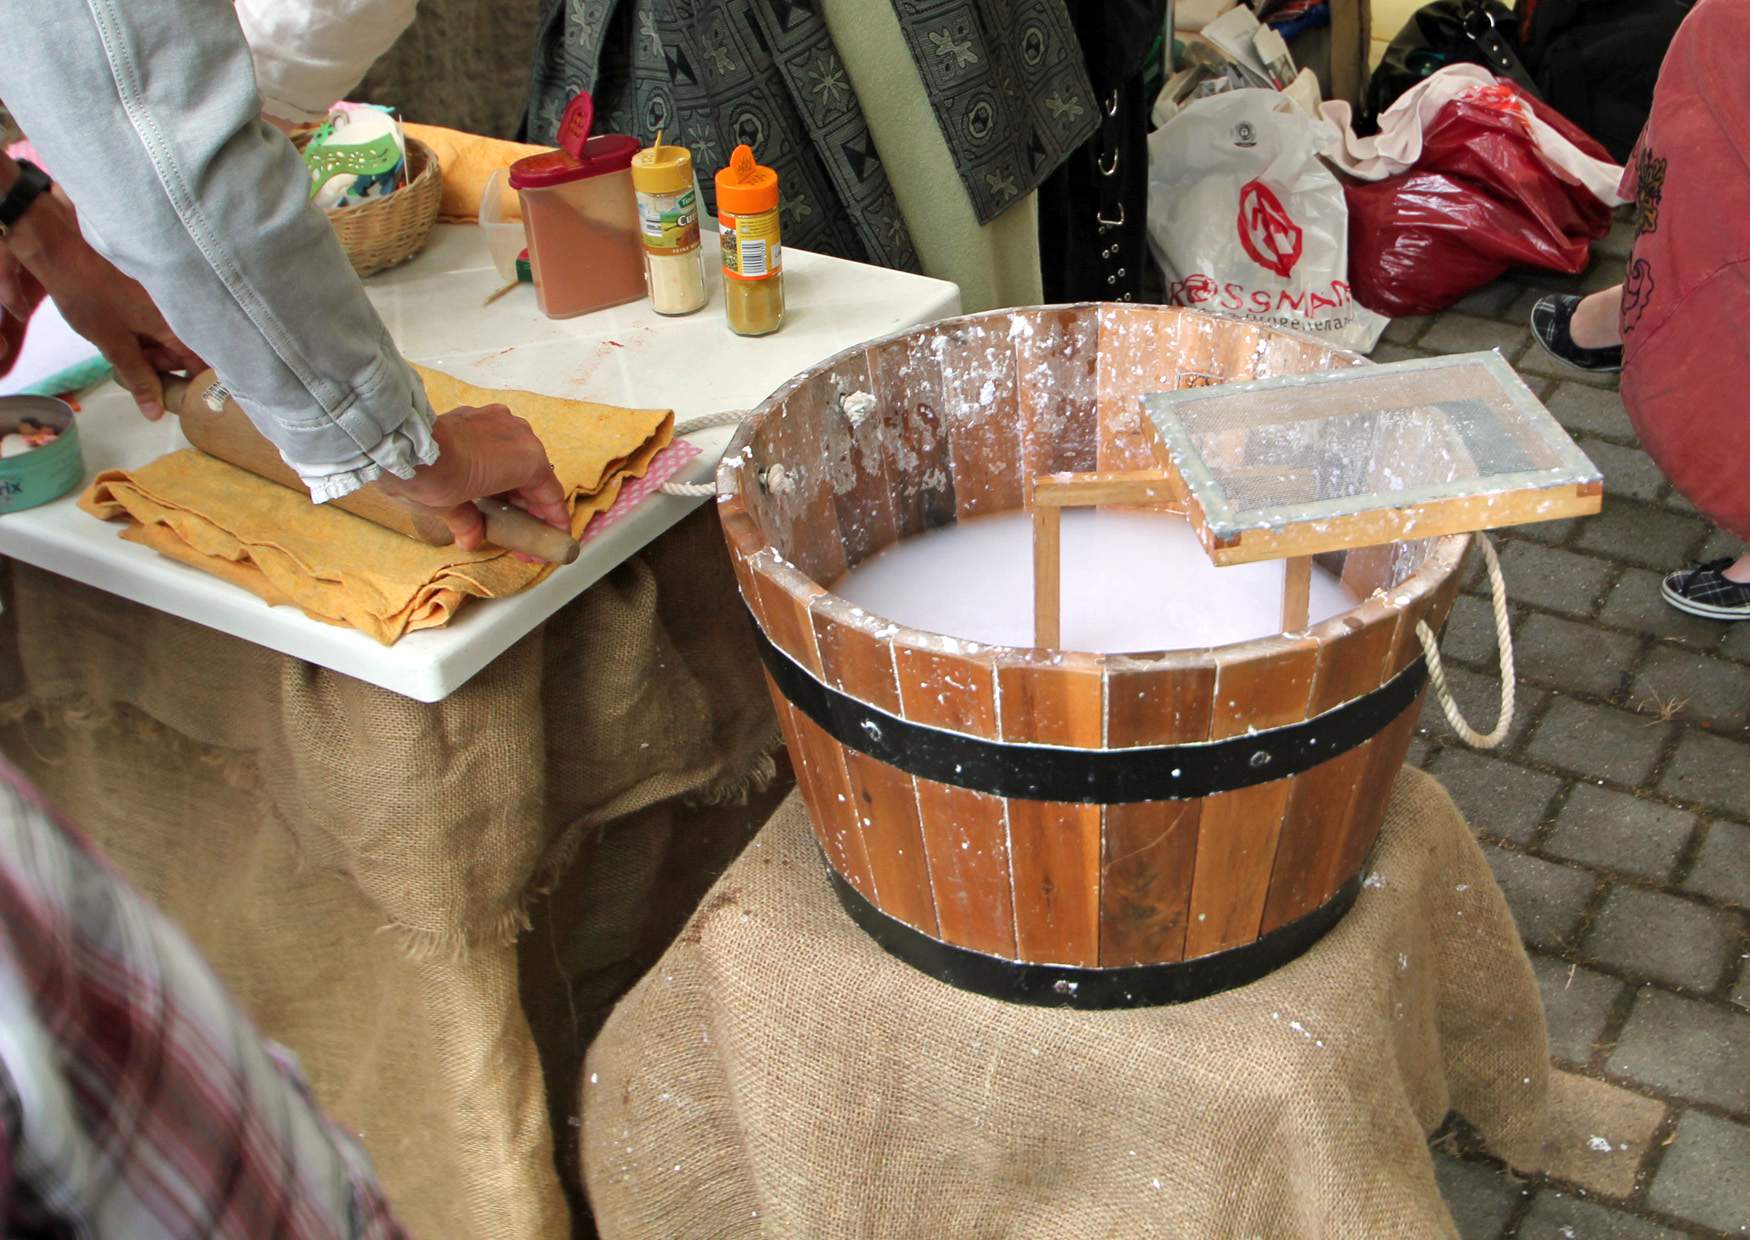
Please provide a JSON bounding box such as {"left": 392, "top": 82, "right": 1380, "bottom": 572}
{"left": 581, "top": 768, "right": 1549, "bottom": 1240}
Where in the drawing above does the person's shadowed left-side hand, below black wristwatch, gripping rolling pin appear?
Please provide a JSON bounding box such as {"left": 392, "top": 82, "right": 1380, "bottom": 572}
{"left": 0, "top": 189, "right": 207, "bottom": 421}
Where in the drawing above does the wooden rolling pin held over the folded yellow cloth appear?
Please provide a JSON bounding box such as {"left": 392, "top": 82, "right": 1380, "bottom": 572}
{"left": 147, "top": 371, "right": 579, "bottom": 563}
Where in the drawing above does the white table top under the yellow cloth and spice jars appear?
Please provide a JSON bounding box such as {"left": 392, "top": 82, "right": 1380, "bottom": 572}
{"left": 0, "top": 226, "right": 959, "bottom": 701}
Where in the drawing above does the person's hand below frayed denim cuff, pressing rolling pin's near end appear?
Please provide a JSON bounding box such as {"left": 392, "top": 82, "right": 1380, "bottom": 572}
{"left": 376, "top": 404, "right": 571, "bottom": 563}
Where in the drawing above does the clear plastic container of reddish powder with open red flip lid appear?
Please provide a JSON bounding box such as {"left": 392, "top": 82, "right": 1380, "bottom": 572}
{"left": 511, "top": 94, "right": 644, "bottom": 318}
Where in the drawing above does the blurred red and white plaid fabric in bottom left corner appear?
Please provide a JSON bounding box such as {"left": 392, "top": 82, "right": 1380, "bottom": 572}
{"left": 0, "top": 763, "right": 403, "bottom": 1240}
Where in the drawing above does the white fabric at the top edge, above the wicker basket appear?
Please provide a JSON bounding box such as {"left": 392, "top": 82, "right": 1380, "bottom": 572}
{"left": 236, "top": 0, "right": 418, "bottom": 121}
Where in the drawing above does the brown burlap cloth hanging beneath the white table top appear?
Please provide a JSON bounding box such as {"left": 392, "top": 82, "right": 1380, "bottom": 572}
{"left": 0, "top": 509, "right": 777, "bottom": 1240}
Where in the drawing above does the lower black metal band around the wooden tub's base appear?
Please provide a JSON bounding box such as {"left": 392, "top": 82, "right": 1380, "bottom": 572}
{"left": 826, "top": 864, "right": 1362, "bottom": 1009}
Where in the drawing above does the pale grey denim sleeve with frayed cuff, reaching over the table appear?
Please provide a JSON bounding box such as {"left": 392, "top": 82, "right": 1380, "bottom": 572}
{"left": 0, "top": 0, "right": 436, "bottom": 498}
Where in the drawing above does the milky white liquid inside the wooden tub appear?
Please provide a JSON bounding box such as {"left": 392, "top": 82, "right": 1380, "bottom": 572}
{"left": 833, "top": 509, "right": 1356, "bottom": 654}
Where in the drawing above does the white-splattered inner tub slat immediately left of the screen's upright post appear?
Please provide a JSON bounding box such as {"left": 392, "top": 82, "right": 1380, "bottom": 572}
{"left": 940, "top": 317, "right": 1022, "bottom": 518}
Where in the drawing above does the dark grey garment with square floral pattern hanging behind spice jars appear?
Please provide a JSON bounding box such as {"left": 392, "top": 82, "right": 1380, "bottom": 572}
{"left": 529, "top": 0, "right": 1096, "bottom": 271}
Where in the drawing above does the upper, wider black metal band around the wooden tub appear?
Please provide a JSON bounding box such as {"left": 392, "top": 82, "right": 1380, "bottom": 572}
{"left": 754, "top": 623, "right": 1428, "bottom": 805}
